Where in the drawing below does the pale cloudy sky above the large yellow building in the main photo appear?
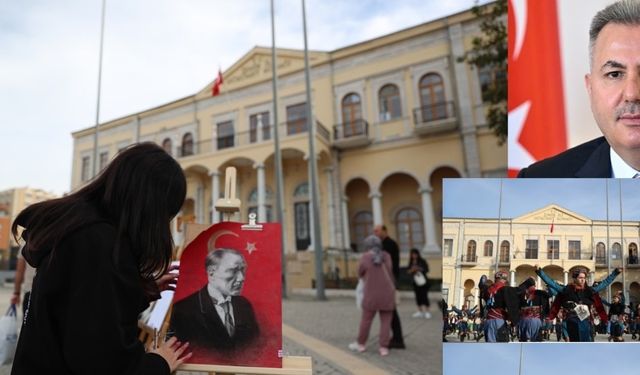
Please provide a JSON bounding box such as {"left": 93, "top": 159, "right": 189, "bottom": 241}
{"left": 0, "top": 0, "right": 487, "bottom": 197}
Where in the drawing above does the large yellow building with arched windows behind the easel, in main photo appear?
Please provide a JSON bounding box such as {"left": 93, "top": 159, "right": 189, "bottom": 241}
{"left": 72, "top": 6, "right": 507, "bottom": 287}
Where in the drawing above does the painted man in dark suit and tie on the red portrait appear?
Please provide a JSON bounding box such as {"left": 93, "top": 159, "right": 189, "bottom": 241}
{"left": 171, "top": 249, "right": 259, "bottom": 351}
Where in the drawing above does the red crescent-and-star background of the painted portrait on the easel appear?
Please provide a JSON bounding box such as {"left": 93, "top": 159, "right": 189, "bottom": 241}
{"left": 169, "top": 222, "right": 282, "bottom": 368}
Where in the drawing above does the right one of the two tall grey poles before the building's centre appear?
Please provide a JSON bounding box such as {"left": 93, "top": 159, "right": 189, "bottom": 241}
{"left": 302, "top": 0, "right": 327, "bottom": 300}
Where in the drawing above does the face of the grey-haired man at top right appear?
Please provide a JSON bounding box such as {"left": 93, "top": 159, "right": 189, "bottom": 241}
{"left": 585, "top": 24, "right": 640, "bottom": 161}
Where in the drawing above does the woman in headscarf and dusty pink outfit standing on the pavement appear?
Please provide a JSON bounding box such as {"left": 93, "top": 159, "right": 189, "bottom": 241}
{"left": 349, "top": 235, "right": 395, "bottom": 356}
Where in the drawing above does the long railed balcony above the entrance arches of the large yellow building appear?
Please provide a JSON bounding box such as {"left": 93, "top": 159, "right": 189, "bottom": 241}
{"left": 174, "top": 121, "right": 331, "bottom": 159}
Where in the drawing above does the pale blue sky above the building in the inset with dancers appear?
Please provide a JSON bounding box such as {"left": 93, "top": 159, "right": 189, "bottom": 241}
{"left": 443, "top": 178, "right": 640, "bottom": 220}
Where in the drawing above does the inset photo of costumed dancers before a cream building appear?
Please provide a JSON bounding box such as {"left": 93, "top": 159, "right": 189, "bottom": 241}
{"left": 441, "top": 179, "right": 640, "bottom": 343}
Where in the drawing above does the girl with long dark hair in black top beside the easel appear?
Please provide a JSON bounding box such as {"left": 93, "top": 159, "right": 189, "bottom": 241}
{"left": 11, "top": 143, "right": 190, "bottom": 374}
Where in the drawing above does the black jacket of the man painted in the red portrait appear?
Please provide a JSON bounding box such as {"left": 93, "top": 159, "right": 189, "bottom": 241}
{"left": 171, "top": 285, "right": 259, "bottom": 352}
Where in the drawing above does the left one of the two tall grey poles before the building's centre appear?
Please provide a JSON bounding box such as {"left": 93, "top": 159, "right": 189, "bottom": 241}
{"left": 270, "top": 0, "right": 287, "bottom": 298}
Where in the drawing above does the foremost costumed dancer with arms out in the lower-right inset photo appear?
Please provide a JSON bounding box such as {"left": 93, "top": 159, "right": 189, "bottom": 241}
{"left": 549, "top": 267, "right": 607, "bottom": 342}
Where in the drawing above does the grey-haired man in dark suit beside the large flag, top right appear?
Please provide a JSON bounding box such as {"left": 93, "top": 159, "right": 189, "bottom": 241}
{"left": 518, "top": 0, "right": 640, "bottom": 178}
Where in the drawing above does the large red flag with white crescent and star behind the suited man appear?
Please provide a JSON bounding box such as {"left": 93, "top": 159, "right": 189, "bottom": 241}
{"left": 508, "top": 0, "right": 567, "bottom": 177}
